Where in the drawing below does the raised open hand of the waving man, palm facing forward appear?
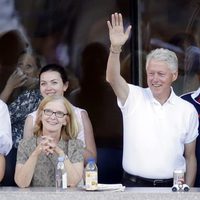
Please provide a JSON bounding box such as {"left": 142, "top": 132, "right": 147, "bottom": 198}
{"left": 107, "top": 13, "right": 131, "bottom": 50}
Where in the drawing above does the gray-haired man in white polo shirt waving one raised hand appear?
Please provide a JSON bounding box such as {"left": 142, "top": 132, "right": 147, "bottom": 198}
{"left": 106, "top": 13, "right": 198, "bottom": 187}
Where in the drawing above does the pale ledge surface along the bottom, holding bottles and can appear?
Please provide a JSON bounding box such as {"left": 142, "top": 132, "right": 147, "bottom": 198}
{"left": 0, "top": 187, "right": 200, "bottom": 200}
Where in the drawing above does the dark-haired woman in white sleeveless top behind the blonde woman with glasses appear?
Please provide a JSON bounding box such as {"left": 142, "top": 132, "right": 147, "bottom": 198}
{"left": 24, "top": 64, "right": 96, "bottom": 163}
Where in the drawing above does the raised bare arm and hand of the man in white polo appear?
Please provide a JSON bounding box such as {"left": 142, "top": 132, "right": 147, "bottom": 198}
{"left": 106, "top": 13, "right": 131, "bottom": 104}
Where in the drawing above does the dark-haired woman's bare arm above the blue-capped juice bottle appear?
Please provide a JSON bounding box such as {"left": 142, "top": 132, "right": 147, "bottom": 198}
{"left": 81, "top": 111, "right": 97, "bottom": 164}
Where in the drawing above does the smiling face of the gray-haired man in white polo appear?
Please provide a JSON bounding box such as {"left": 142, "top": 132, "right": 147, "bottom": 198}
{"left": 146, "top": 59, "right": 178, "bottom": 102}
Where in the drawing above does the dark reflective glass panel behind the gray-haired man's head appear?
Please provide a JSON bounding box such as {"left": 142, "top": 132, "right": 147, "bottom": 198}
{"left": 139, "top": 0, "right": 200, "bottom": 94}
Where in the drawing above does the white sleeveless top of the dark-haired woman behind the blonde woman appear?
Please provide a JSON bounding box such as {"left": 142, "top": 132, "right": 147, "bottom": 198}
{"left": 28, "top": 105, "right": 86, "bottom": 147}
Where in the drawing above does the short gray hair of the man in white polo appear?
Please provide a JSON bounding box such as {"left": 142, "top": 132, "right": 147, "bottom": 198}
{"left": 146, "top": 48, "right": 178, "bottom": 72}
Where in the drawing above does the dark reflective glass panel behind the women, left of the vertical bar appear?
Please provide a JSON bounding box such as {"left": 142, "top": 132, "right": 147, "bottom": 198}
{"left": 0, "top": 0, "right": 131, "bottom": 150}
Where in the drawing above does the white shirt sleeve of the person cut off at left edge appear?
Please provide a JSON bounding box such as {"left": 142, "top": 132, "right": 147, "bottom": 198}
{"left": 0, "top": 100, "right": 12, "bottom": 155}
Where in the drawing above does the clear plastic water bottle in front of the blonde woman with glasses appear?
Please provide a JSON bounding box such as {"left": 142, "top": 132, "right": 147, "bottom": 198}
{"left": 56, "top": 156, "right": 67, "bottom": 189}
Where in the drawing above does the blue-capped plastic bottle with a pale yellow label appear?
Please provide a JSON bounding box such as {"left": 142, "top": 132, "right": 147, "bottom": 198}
{"left": 85, "top": 158, "right": 98, "bottom": 190}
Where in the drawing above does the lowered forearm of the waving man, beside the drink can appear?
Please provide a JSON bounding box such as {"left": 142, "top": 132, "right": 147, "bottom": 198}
{"left": 185, "top": 140, "right": 197, "bottom": 187}
